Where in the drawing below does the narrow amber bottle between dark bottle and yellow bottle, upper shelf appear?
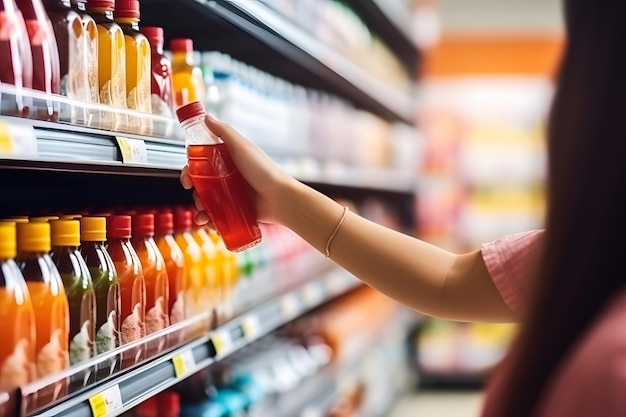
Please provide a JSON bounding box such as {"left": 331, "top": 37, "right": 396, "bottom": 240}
{"left": 71, "top": 0, "right": 100, "bottom": 109}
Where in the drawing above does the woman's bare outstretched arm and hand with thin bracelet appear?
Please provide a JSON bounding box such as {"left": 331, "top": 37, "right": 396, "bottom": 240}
{"left": 181, "top": 117, "right": 516, "bottom": 322}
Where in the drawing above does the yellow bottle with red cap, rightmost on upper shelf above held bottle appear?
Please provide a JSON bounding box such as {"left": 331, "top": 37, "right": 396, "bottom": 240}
{"left": 170, "top": 38, "right": 206, "bottom": 109}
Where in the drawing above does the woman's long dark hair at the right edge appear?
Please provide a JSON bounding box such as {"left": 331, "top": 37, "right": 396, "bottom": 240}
{"left": 487, "top": 0, "right": 626, "bottom": 417}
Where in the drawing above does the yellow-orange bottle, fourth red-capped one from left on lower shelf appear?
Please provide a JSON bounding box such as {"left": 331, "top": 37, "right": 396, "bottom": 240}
{"left": 174, "top": 209, "right": 209, "bottom": 336}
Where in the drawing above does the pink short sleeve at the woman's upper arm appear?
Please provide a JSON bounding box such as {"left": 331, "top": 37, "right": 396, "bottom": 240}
{"left": 481, "top": 230, "right": 544, "bottom": 316}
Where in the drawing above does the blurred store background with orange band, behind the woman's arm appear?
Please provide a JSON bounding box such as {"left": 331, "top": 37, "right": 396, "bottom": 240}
{"left": 392, "top": 0, "right": 564, "bottom": 417}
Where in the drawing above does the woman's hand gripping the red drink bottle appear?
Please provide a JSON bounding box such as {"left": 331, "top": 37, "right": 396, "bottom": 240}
{"left": 180, "top": 115, "right": 297, "bottom": 228}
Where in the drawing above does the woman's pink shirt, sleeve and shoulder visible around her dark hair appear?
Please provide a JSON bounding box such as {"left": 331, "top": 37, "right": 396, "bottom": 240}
{"left": 482, "top": 231, "right": 626, "bottom": 417}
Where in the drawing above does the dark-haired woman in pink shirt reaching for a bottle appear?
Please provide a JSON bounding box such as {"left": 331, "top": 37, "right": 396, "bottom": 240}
{"left": 181, "top": 0, "right": 626, "bottom": 417}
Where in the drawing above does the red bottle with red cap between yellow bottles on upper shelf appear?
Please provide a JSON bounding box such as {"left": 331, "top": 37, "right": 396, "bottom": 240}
{"left": 141, "top": 26, "right": 174, "bottom": 116}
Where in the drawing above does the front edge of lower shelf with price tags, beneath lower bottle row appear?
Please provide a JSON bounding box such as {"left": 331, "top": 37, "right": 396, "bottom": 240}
{"left": 30, "top": 268, "right": 359, "bottom": 417}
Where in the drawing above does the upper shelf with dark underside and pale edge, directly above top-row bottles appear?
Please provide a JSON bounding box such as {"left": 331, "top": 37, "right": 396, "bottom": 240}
{"left": 141, "top": 0, "right": 416, "bottom": 124}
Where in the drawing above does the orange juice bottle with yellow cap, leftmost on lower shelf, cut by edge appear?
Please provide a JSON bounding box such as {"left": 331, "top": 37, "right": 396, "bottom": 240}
{"left": 0, "top": 222, "right": 36, "bottom": 389}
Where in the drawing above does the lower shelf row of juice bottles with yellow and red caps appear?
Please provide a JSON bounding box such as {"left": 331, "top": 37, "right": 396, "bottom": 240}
{"left": 0, "top": 207, "right": 326, "bottom": 413}
